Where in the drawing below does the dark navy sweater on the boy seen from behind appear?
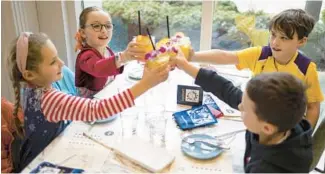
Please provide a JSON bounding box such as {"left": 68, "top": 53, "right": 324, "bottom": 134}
{"left": 195, "top": 68, "right": 312, "bottom": 173}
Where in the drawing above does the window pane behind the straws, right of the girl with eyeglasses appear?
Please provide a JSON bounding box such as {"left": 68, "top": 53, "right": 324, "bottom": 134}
{"left": 102, "top": 0, "right": 202, "bottom": 51}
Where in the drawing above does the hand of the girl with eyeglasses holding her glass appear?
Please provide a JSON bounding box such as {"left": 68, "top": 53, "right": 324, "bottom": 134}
{"left": 121, "top": 41, "right": 146, "bottom": 62}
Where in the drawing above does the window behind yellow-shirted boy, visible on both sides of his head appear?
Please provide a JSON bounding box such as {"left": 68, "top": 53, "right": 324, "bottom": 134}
{"left": 211, "top": 0, "right": 325, "bottom": 72}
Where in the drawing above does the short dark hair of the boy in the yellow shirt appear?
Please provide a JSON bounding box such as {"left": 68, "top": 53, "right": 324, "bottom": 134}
{"left": 269, "top": 9, "right": 315, "bottom": 40}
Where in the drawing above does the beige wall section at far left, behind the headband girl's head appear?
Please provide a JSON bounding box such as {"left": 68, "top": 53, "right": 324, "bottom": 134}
{"left": 1, "top": 1, "right": 39, "bottom": 101}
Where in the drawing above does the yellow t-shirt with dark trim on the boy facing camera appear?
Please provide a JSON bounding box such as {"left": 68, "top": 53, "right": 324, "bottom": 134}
{"left": 236, "top": 47, "right": 324, "bottom": 103}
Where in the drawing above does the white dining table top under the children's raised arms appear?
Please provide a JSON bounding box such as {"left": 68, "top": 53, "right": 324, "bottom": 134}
{"left": 22, "top": 62, "right": 248, "bottom": 173}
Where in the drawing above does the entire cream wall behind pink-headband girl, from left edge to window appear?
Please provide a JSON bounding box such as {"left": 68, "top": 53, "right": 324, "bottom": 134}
{"left": 1, "top": 1, "right": 81, "bottom": 101}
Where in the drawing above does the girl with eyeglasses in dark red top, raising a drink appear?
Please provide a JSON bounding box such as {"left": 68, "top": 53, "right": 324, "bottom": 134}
{"left": 75, "top": 7, "right": 145, "bottom": 98}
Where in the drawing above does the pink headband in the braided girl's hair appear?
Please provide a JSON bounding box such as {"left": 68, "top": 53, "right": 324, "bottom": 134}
{"left": 16, "top": 32, "right": 32, "bottom": 73}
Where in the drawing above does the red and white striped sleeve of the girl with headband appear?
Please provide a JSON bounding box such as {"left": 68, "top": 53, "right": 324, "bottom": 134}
{"left": 41, "top": 89, "right": 134, "bottom": 122}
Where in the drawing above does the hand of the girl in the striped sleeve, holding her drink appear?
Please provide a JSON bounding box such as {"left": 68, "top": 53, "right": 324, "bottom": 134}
{"left": 141, "top": 63, "right": 170, "bottom": 88}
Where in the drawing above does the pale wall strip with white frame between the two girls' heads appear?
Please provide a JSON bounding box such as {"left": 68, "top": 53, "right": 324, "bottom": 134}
{"left": 36, "top": 1, "right": 81, "bottom": 70}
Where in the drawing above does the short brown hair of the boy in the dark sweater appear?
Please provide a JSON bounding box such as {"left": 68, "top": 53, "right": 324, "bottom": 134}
{"left": 246, "top": 72, "right": 307, "bottom": 132}
